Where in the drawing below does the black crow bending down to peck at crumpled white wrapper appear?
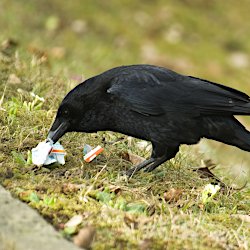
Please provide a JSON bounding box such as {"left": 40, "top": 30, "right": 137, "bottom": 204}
{"left": 48, "top": 65, "right": 250, "bottom": 176}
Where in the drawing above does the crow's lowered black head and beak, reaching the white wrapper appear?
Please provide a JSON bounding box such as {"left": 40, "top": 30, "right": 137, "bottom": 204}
{"left": 47, "top": 79, "right": 106, "bottom": 143}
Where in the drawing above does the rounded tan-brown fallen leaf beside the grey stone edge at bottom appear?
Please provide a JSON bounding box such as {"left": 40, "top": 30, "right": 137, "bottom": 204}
{"left": 73, "top": 226, "right": 95, "bottom": 248}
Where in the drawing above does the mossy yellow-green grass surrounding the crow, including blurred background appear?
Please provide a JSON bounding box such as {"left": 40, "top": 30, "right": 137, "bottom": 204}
{"left": 0, "top": 0, "right": 250, "bottom": 249}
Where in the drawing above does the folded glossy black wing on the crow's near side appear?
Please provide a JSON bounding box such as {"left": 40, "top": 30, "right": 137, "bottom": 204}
{"left": 107, "top": 71, "right": 250, "bottom": 116}
